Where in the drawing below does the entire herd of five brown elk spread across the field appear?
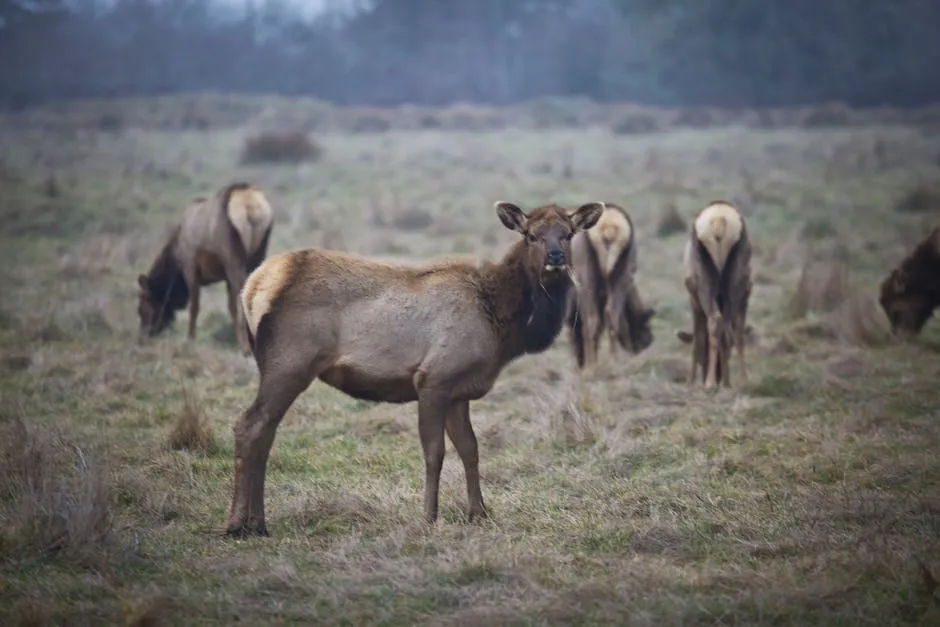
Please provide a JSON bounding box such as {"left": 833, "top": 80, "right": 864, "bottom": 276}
{"left": 132, "top": 183, "right": 940, "bottom": 537}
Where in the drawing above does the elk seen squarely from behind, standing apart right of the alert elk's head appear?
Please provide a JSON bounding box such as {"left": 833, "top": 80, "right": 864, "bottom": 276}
{"left": 678, "top": 201, "right": 752, "bottom": 388}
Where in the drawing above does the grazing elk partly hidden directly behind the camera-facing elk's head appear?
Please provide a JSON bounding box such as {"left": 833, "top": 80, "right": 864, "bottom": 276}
{"left": 568, "top": 203, "right": 655, "bottom": 368}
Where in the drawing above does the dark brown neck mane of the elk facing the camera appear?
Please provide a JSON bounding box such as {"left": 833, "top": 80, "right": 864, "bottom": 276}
{"left": 481, "top": 242, "right": 571, "bottom": 364}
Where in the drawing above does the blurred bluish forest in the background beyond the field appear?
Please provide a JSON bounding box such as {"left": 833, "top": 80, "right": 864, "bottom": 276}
{"left": 0, "top": 0, "right": 940, "bottom": 109}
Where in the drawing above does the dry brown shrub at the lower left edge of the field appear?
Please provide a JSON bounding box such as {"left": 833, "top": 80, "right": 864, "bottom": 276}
{"left": 0, "top": 419, "right": 115, "bottom": 566}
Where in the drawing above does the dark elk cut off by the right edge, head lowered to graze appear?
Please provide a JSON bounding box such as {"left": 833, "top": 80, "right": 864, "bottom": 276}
{"left": 878, "top": 226, "right": 940, "bottom": 337}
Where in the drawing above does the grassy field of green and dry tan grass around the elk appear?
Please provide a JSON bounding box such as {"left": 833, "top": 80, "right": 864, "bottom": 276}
{"left": 0, "top": 99, "right": 940, "bottom": 626}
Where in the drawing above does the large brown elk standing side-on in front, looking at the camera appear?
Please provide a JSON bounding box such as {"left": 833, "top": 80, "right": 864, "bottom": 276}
{"left": 227, "top": 201, "right": 604, "bottom": 537}
